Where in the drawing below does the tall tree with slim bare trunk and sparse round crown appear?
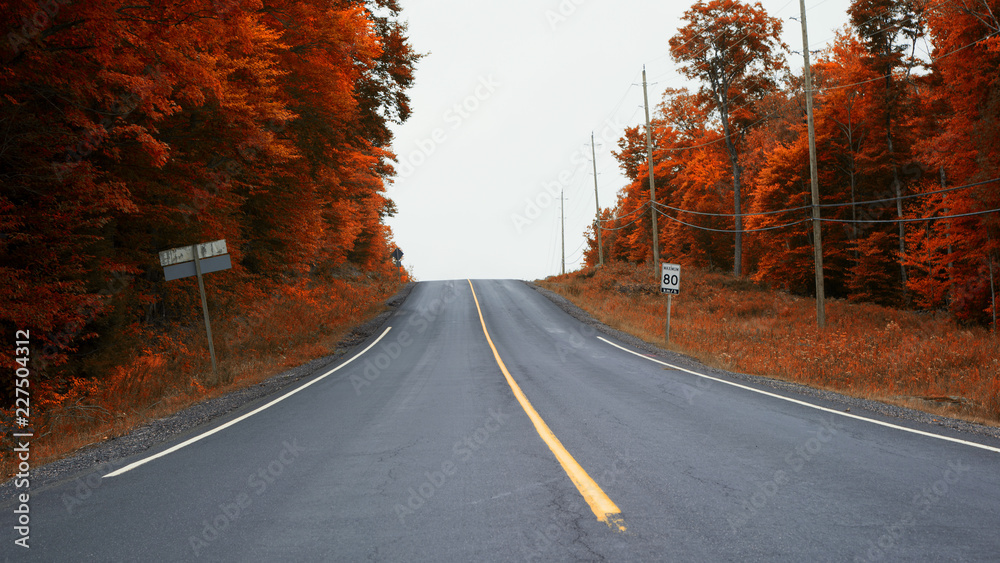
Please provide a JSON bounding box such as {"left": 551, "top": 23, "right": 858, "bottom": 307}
{"left": 670, "top": 0, "right": 786, "bottom": 277}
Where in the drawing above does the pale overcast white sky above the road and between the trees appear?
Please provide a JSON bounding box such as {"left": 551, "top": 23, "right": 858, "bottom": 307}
{"left": 388, "top": 0, "right": 849, "bottom": 281}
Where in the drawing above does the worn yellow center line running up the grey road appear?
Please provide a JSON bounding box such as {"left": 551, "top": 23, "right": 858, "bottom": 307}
{"left": 468, "top": 280, "right": 625, "bottom": 532}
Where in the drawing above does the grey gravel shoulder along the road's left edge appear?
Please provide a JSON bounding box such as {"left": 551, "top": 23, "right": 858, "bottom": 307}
{"left": 0, "top": 282, "right": 416, "bottom": 505}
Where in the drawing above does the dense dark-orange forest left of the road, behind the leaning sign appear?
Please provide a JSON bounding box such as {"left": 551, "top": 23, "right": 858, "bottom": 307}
{"left": 0, "top": 0, "right": 420, "bottom": 442}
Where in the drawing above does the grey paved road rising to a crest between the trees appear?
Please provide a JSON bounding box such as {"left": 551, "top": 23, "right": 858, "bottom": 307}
{"left": 3, "top": 280, "right": 1000, "bottom": 561}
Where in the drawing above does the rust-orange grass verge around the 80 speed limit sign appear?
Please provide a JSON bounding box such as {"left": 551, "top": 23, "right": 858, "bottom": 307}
{"left": 536, "top": 263, "right": 1000, "bottom": 426}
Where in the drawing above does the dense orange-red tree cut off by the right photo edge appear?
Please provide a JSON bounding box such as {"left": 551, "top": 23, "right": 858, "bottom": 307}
{"left": 908, "top": 0, "right": 1000, "bottom": 323}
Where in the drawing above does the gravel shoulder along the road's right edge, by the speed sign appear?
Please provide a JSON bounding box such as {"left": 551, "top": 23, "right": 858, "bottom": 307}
{"left": 525, "top": 282, "right": 1000, "bottom": 441}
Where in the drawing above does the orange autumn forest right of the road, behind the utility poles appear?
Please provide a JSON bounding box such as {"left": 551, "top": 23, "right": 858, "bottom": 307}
{"left": 585, "top": 0, "right": 1000, "bottom": 326}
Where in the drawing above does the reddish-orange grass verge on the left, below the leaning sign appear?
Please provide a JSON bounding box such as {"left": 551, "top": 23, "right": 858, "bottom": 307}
{"left": 0, "top": 280, "right": 399, "bottom": 480}
